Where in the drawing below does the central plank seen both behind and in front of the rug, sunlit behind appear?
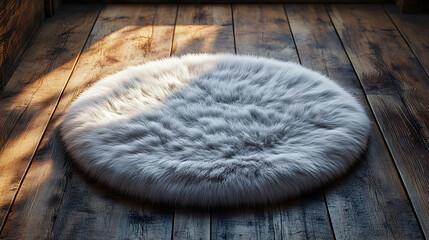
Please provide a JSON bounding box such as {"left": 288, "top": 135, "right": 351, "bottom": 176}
{"left": 172, "top": 5, "right": 234, "bottom": 239}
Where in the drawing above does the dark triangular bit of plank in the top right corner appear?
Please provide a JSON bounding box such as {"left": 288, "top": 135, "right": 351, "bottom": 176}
{"left": 384, "top": 4, "right": 429, "bottom": 75}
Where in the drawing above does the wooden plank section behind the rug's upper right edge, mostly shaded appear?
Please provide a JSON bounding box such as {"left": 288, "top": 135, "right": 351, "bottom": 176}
{"left": 285, "top": 5, "right": 364, "bottom": 95}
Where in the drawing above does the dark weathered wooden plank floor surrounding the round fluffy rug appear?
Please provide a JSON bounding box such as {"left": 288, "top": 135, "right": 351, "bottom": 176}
{"left": 0, "top": 2, "right": 429, "bottom": 239}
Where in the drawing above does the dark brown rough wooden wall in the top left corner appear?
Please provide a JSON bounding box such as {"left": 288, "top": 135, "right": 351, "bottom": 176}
{"left": 0, "top": 0, "right": 45, "bottom": 91}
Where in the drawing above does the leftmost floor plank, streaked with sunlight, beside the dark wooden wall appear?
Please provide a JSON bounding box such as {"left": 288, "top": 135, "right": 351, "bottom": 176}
{"left": 0, "top": 5, "right": 99, "bottom": 234}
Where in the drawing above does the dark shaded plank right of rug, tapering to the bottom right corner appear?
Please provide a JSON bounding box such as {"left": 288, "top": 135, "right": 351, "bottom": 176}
{"left": 368, "top": 95, "right": 429, "bottom": 238}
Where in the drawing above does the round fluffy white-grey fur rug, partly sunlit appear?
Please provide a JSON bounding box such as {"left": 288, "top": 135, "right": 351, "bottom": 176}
{"left": 60, "top": 54, "right": 370, "bottom": 207}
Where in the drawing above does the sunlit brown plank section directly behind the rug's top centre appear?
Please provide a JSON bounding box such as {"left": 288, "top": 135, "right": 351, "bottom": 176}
{"left": 172, "top": 5, "right": 234, "bottom": 55}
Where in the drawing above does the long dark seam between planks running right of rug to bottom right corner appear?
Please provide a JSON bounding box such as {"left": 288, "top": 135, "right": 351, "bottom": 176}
{"left": 324, "top": 4, "right": 424, "bottom": 238}
